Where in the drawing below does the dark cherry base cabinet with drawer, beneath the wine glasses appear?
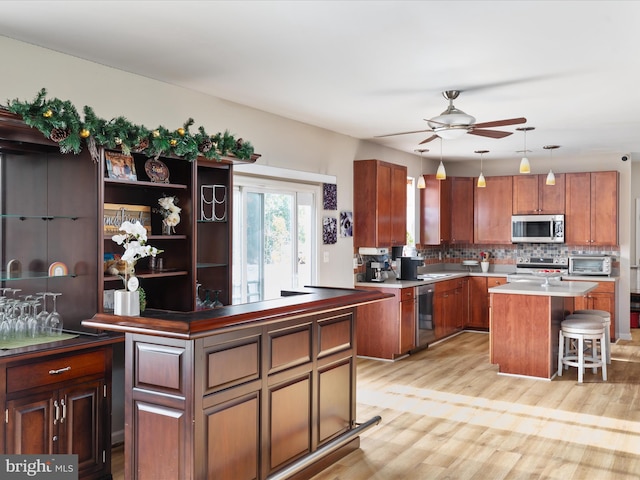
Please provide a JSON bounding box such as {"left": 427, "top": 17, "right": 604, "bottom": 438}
{"left": 3, "top": 347, "right": 112, "bottom": 479}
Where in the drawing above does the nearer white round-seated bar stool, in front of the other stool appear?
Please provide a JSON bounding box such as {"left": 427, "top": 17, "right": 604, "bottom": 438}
{"left": 558, "top": 314, "right": 607, "bottom": 383}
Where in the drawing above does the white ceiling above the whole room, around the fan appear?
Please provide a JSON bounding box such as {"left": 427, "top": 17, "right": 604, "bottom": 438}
{"left": 0, "top": 0, "right": 640, "bottom": 161}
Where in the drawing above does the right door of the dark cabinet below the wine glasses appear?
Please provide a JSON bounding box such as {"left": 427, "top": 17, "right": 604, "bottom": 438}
{"left": 58, "top": 381, "right": 106, "bottom": 477}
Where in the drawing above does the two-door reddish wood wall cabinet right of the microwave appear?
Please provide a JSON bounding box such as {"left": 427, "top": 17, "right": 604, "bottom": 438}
{"left": 565, "top": 171, "right": 619, "bottom": 246}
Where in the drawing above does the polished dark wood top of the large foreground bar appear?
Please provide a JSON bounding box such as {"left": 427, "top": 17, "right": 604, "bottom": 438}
{"left": 82, "top": 287, "right": 392, "bottom": 339}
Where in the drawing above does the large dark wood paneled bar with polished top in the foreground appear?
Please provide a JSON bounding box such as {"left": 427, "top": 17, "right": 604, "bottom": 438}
{"left": 83, "top": 287, "right": 389, "bottom": 480}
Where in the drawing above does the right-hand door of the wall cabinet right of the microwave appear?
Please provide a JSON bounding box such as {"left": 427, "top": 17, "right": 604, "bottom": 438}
{"left": 591, "top": 172, "right": 619, "bottom": 245}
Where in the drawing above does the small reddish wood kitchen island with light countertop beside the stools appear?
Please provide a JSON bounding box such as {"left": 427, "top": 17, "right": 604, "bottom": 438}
{"left": 489, "top": 279, "right": 598, "bottom": 379}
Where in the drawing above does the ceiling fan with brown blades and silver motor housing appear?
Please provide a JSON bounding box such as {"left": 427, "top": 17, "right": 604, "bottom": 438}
{"left": 377, "top": 90, "right": 527, "bottom": 145}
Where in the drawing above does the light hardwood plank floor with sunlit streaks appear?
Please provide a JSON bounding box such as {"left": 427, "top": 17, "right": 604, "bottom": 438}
{"left": 113, "top": 329, "right": 640, "bottom": 480}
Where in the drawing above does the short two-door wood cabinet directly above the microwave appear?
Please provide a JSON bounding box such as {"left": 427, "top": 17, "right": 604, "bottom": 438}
{"left": 512, "top": 173, "right": 565, "bottom": 215}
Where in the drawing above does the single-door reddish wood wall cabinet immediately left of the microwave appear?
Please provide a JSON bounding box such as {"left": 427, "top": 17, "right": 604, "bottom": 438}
{"left": 473, "top": 176, "right": 513, "bottom": 244}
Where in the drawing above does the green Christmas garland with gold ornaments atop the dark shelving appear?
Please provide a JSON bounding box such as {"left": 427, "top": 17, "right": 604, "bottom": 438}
{"left": 5, "top": 88, "right": 253, "bottom": 162}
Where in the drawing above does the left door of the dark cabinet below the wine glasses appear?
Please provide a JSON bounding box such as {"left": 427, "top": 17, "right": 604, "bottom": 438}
{"left": 6, "top": 392, "right": 53, "bottom": 455}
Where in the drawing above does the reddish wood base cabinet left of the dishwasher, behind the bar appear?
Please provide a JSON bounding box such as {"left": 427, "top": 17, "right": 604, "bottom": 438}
{"left": 356, "top": 287, "right": 417, "bottom": 359}
